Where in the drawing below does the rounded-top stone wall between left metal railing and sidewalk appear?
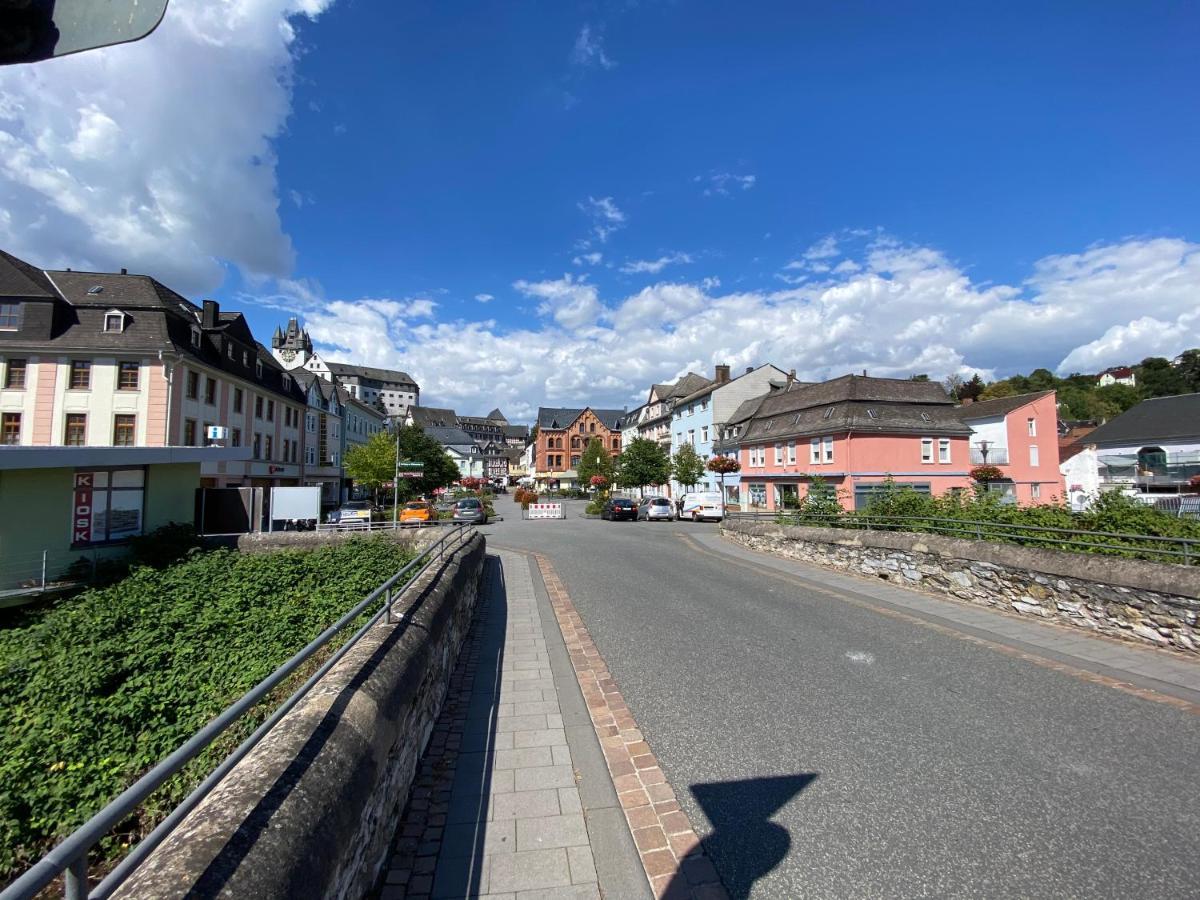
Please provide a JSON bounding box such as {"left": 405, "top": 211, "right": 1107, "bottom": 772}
{"left": 118, "top": 534, "right": 485, "bottom": 900}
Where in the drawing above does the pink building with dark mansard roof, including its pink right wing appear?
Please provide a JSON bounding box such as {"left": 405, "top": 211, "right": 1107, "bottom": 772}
{"left": 738, "top": 376, "right": 1061, "bottom": 510}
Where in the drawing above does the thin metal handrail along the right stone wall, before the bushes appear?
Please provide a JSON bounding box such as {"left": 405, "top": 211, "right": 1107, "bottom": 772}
{"left": 727, "top": 510, "right": 1200, "bottom": 565}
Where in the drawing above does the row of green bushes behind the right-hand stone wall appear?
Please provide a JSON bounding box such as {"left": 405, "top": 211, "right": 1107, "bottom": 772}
{"left": 779, "top": 485, "right": 1200, "bottom": 564}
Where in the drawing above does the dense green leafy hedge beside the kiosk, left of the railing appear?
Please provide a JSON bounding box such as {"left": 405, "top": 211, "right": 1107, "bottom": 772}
{"left": 0, "top": 538, "right": 413, "bottom": 882}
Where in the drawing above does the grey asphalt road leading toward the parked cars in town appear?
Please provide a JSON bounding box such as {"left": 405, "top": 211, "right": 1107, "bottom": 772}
{"left": 486, "top": 498, "right": 1200, "bottom": 898}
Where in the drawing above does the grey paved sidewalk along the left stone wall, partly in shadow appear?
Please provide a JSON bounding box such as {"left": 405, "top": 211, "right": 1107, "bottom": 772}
{"left": 379, "top": 552, "right": 644, "bottom": 900}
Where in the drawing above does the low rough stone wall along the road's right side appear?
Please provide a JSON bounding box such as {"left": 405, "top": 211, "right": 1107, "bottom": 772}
{"left": 721, "top": 521, "right": 1200, "bottom": 655}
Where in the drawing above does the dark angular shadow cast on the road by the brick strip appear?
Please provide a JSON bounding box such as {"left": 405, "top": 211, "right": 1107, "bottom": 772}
{"left": 666, "top": 773, "right": 817, "bottom": 900}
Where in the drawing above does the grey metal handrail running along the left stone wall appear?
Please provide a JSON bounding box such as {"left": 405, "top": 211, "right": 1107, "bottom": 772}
{"left": 0, "top": 523, "right": 470, "bottom": 900}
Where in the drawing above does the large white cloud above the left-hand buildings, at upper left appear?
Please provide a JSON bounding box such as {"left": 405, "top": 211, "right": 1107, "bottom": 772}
{"left": 0, "top": 0, "right": 331, "bottom": 293}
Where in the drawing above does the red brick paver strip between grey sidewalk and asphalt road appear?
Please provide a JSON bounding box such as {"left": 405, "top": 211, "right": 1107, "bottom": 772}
{"left": 534, "top": 553, "right": 727, "bottom": 900}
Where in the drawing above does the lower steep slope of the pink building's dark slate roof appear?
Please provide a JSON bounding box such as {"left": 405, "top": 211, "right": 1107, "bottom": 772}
{"left": 742, "top": 401, "right": 971, "bottom": 440}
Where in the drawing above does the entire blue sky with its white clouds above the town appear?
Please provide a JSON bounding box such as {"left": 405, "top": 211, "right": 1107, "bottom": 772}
{"left": 0, "top": 0, "right": 1200, "bottom": 415}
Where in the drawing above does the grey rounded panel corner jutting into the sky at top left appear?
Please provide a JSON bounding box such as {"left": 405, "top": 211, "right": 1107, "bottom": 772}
{"left": 0, "top": 0, "right": 167, "bottom": 66}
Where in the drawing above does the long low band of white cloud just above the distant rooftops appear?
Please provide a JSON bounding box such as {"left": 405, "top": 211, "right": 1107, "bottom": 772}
{"left": 274, "top": 232, "right": 1200, "bottom": 418}
